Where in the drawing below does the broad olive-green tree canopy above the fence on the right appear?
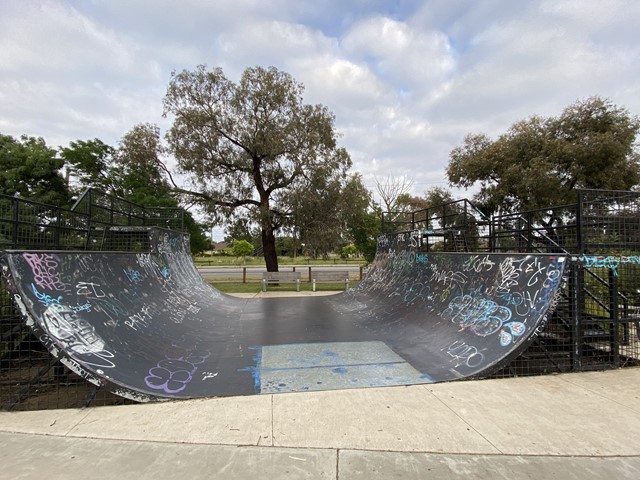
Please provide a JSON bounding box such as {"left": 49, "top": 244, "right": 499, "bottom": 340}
{"left": 447, "top": 97, "right": 640, "bottom": 214}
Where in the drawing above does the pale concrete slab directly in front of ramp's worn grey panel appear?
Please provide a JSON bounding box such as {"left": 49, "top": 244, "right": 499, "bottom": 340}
{"left": 273, "top": 386, "right": 498, "bottom": 453}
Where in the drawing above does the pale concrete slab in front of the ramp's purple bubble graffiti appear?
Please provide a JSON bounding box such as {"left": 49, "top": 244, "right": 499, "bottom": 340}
{"left": 68, "top": 396, "right": 272, "bottom": 445}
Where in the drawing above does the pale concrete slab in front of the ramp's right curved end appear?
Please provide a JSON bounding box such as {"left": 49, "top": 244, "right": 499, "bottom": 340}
{"left": 422, "top": 374, "right": 640, "bottom": 456}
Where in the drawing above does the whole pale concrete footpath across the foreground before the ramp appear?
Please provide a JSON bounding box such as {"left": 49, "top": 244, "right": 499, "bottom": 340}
{"left": 0, "top": 369, "right": 640, "bottom": 480}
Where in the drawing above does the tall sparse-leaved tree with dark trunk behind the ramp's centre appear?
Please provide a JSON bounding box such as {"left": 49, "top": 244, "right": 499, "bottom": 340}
{"left": 159, "top": 65, "right": 351, "bottom": 271}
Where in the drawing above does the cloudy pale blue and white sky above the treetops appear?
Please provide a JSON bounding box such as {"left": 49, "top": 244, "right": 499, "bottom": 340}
{"left": 0, "top": 0, "right": 640, "bottom": 204}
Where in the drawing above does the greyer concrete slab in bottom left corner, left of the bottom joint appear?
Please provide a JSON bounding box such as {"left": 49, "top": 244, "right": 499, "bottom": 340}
{"left": 0, "top": 433, "right": 337, "bottom": 480}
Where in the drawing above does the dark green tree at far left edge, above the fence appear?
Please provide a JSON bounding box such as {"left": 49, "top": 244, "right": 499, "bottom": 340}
{"left": 0, "top": 134, "right": 70, "bottom": 206}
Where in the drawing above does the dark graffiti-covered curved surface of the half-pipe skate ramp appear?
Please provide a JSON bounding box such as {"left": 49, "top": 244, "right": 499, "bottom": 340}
{"left": 1, "top": 229, "right": 567, "bottom": 401}
